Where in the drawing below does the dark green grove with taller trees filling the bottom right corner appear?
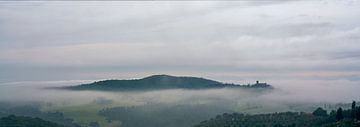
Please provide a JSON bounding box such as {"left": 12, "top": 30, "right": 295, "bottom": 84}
{"left": 194, "top": 102, "right": 360, "bottom": 127}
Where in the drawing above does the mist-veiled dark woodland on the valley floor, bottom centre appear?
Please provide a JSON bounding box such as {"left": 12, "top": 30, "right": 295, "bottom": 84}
{"left": 98, "top": 103, "right": 231, "bottom": 127}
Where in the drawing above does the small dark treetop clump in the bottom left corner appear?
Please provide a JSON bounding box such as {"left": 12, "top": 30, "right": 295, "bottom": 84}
{"left": 0, "top": 115, "right": 64, "bottom": 127}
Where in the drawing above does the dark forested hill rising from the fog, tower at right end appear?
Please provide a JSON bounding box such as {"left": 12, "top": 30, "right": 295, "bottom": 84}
{"left": 65, "top": 75, "right": 272, "bottom": 91}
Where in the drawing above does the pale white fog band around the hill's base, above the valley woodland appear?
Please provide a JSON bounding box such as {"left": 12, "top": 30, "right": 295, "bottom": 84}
{"left": 0, "top": 80, "right": 360, "bottom": 112}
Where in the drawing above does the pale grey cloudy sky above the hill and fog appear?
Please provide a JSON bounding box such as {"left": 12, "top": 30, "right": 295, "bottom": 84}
{"left": 0, "top": 0, "right": 360, "bottom": 84}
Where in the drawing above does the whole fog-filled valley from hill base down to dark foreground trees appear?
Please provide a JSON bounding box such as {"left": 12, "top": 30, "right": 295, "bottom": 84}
{"left": 0, "top": 80, "right": 360, "bottom": 127}
